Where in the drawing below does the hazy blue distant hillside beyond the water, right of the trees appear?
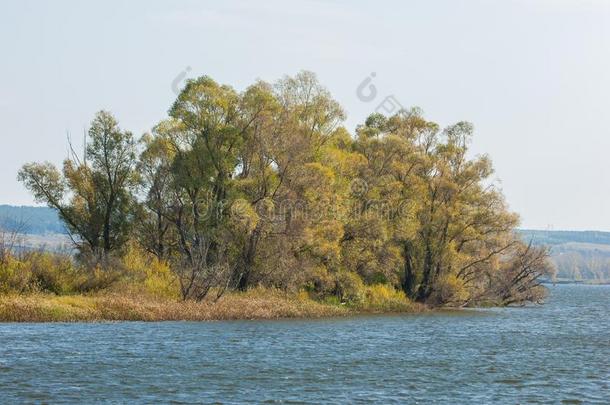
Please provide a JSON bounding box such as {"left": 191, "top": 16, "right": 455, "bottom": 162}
{"left": 519, "top": 230, "right": 610, "bottom": 283}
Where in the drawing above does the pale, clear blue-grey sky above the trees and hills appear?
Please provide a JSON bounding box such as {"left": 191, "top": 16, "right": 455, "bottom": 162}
{"left": 0, "top": 0, "right": 610, "bottom": 231}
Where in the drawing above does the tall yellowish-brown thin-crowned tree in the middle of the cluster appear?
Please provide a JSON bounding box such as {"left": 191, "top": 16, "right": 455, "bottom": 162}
{"left": 228, "top": 72, "right": 344, "bottom": 290}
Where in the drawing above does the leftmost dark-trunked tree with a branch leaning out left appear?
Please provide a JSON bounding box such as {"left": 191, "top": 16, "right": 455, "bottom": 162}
{"left": 18, "top": 111, "right": 137, "bottom": 254}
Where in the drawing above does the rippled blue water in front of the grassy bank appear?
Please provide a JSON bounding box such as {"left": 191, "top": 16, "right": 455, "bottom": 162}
{"left": 0, "top": 285, "right": 610, "bottom": 404}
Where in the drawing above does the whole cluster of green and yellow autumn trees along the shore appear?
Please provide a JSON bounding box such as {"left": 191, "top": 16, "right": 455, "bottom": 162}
{"left": 19, "top": 72, "right": 550, "bottom": 305}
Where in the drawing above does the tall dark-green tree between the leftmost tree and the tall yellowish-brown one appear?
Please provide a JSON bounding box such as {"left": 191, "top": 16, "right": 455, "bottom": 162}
{"left": 158, "top": 76, "right": 262, "bottom": 300}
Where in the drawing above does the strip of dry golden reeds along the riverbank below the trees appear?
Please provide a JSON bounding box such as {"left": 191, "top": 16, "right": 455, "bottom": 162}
{"left": 0, "top": 289, "right": 426, "bottom": 322}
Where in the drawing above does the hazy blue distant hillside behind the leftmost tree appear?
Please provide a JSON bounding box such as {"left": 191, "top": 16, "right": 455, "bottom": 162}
{"left": 0, "top": 205, "right": 65, "bottom": 235}
